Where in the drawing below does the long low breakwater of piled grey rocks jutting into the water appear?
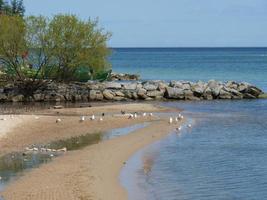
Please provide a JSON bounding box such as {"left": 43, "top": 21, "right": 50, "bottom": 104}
{"left": 0, "top": 80, "right": 263, "bottom": 102}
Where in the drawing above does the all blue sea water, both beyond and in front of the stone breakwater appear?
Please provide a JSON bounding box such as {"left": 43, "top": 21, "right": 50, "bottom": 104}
{"left": 110, "top": 48, "right": 267, "bottom": 200}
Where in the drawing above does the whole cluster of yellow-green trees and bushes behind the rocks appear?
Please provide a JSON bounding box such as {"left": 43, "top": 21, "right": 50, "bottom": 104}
{"left": 0, "top": 0, "right": 111, "bottom": 95}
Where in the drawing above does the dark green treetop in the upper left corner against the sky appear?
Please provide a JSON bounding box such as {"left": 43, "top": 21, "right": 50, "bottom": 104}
{"left": 0, "top": 0, "right": 25, "bottom": 16}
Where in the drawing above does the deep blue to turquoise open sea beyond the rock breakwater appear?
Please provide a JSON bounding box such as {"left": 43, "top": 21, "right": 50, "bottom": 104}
{"left": 110, "top": 48, "right": 267, "bottom": 91}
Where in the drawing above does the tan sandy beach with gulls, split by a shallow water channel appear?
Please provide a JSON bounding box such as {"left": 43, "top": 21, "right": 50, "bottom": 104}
{"left": 0, "top": 104, "right": 182, "bottom": 200}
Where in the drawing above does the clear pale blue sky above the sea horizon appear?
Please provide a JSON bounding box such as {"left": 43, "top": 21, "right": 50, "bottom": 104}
{"left": 24, "top": 0, "right": 267, "bottom": 47}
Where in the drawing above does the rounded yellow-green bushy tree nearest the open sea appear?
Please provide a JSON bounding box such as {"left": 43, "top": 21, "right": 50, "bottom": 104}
{"left": 49, "top": 15, "right": 111, "bottom": 81}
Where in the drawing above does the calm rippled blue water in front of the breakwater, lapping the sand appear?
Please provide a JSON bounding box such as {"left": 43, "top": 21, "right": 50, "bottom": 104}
{"left": 121, "top": 100, "right": 267, "bottom": 200}
